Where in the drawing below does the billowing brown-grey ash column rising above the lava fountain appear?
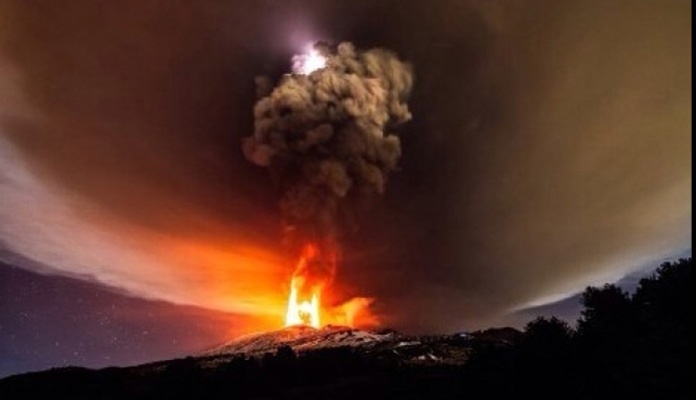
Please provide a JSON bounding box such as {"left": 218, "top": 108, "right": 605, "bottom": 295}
{"left": 243, "top": 42, "right": 413, "bottom": 316}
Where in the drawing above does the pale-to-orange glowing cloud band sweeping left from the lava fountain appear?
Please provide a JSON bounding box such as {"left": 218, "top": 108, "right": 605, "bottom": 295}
{"left": 0, "top": 134, "right": 376, "bottom": 334}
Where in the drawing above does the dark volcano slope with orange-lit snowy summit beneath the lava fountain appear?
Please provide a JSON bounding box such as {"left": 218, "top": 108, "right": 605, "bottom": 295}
{"left": 0, "top": 325, "right": 521, "bottom": 399}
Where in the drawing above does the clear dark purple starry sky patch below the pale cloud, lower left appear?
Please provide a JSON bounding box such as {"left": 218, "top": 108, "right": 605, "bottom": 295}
{"left": 0, "top": 264, "right": 249, "bottom": 376}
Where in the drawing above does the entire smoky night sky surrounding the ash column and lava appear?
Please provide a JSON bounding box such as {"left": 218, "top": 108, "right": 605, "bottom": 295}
{"left": 0, "top": 0, "right": 692, "bottom": 375}
